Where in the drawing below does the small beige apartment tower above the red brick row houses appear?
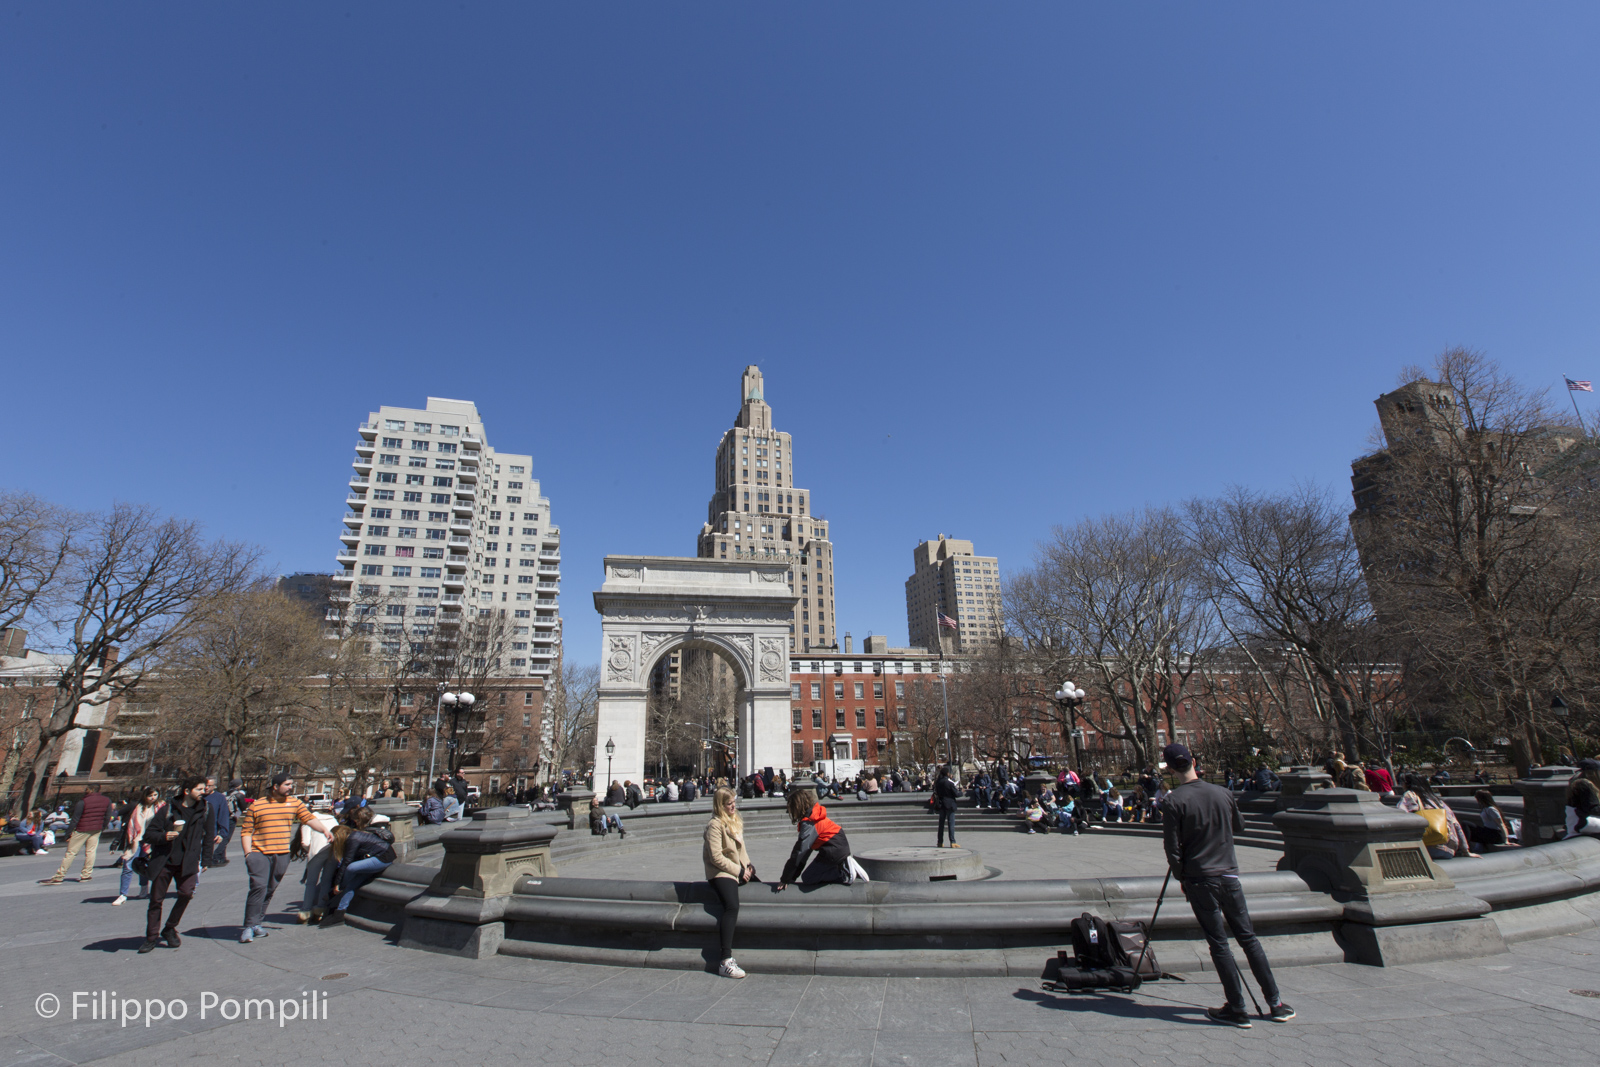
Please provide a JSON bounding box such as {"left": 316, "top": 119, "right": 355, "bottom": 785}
{"left": 906, "top": 534, "right": 1005, "bottom": 654}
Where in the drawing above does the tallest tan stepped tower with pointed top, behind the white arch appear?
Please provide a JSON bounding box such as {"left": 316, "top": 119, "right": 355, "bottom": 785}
{"left": 698, "top": 365, "right": 838, "bottom": 651}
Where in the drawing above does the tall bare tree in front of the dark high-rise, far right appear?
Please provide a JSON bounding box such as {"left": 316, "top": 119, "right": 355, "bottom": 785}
{"left": 1354, "top": 349, "right": 1600, "bottom": 773}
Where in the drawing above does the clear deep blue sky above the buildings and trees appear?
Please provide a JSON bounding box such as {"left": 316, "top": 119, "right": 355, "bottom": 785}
{"left": 0, "top": 0, "right": 1600, "bottom": 661}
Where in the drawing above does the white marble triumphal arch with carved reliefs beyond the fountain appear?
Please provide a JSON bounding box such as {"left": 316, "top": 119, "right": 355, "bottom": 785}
{"left": 594, "top": 555, "right": 795, "bottom": 790}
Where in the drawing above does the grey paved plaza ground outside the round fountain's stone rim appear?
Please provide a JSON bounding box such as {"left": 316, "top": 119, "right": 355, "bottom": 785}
{"left": 0, "top": 835, "right": 1600, "bottom": 1067}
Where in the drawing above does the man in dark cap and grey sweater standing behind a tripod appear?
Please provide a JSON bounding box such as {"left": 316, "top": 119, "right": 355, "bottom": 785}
{"left": 1162, "top": 744, "right": 1294, "bottom": 1029}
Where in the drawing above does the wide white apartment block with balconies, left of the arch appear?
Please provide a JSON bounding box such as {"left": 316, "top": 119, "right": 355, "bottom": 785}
{"left": 333, "top": 397, "right": 562, "bottom": 678}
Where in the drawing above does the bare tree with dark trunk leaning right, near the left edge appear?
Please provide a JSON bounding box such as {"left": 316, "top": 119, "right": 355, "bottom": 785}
{"left": 22, "top": 504, "right": 256, "bottom": 805}
